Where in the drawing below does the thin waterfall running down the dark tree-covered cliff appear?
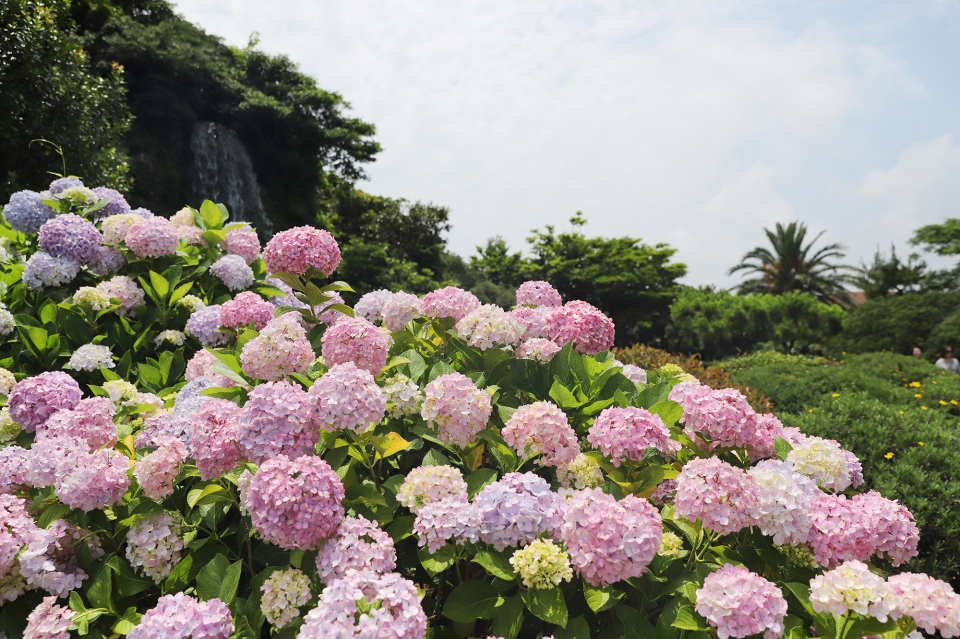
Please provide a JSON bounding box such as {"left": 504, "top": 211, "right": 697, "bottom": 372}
{"left": 190, "top": 122, "right": 273, "bottom": 238}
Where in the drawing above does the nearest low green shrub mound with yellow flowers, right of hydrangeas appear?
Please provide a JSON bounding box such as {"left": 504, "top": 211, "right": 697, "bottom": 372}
{"left": 780, "top": 396, "right": 960, "bottom": 586}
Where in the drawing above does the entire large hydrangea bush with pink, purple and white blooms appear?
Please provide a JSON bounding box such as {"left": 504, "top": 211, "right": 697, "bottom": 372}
{"left": 0, "top": 180, "right": 960, "bottom": 639}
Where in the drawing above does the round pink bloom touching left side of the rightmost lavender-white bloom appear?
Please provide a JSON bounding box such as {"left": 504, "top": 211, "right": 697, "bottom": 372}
{"left": 674, "top": 457, "right": 760, "bottom": 534}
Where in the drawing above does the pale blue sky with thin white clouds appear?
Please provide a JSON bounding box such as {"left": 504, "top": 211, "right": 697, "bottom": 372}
{"left": 177, "top": 0, "right": 960, "bottom": 286}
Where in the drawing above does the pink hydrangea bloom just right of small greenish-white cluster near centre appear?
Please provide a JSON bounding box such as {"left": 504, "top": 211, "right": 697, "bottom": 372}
{"left": 420, "top": 373, "right": 493, "bottom": 448}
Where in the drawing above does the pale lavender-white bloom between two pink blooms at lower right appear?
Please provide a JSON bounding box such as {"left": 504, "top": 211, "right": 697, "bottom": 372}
{"left": 747, "top": 459, "right": 822, "bottom": 546}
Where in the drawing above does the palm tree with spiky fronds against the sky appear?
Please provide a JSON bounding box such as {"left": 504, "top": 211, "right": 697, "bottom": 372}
{"left": 730, "top": 222, "right": 851, "bottom": 303}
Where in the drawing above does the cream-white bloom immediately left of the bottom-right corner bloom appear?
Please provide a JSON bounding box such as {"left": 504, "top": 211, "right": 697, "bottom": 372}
{"left": 810, "top": 561, "right": 900, "bottom": 621}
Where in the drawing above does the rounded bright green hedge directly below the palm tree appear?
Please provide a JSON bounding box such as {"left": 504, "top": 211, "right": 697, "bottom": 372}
{"left": 667, "top": 287, "right": 844, "bottom": 360}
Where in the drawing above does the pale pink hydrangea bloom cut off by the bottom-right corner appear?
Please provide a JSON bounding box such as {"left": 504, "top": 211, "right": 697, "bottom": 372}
{"left": 887, "top": 572, "right": 960, "bottom": 637}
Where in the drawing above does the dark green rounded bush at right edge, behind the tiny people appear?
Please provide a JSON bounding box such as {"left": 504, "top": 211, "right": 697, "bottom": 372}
{"left": 831, "top": 293, "right": 960, "bottom": 359}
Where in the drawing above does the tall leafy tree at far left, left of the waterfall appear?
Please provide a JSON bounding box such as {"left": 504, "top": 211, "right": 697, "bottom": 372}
{"left": 0, "top": 0, "right": 130, "bottom": 202}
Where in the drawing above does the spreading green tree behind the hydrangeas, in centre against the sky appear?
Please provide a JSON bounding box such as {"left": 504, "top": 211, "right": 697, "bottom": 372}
{"left": 471, "top": 213, "right": 687, "bottom": 346}
